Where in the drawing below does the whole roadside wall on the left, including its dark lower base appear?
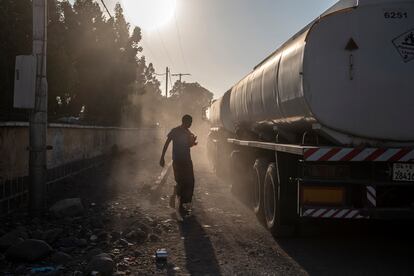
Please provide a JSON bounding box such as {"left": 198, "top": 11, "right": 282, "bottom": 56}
{"left": 0, "top": 122, "right": 164, "bottom": 214}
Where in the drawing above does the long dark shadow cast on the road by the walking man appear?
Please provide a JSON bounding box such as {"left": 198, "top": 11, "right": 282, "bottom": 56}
{"left": 179, "top": 215, "right": 221, "bottom": 275}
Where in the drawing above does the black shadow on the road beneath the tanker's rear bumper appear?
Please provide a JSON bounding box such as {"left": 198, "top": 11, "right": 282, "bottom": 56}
{"left": 277, "top": 222, "right": 414, "bottom": 275}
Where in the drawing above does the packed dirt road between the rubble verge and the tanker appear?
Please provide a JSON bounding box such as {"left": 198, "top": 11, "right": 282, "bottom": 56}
{"left": 107, "top": 149, "right": 414, "bottom": 275}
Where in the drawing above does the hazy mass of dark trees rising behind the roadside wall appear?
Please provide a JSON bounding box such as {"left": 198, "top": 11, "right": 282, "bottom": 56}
{"left": 0, "top": 0, "right": 212, "bottom": 129}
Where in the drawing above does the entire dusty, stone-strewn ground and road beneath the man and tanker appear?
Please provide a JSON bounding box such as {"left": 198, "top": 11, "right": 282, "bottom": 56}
{"left": 0, "top": 145, "right": 414, "bottom": 275}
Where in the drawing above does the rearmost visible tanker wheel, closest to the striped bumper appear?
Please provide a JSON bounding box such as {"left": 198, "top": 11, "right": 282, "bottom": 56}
{"left": 263, "top": 163, "right": 294, "bottom": 237}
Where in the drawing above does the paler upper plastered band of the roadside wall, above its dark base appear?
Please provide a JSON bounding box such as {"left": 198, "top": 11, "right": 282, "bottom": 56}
{"left": 0, "top": 122, "right": 163, "bottom": 179}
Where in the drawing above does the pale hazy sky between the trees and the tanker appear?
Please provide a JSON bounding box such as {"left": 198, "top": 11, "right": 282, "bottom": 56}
{"left": 100, "top": 0, "right": 337, "bottom": 97}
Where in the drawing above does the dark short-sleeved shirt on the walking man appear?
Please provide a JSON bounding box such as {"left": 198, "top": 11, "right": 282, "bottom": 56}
{"left": 168, "top": 126, "right": 192, "bottom": 162}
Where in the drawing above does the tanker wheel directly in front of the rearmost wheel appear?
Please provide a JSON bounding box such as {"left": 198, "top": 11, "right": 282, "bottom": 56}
{"left": 252, "top": 158, "right": 269, "bottom": 222}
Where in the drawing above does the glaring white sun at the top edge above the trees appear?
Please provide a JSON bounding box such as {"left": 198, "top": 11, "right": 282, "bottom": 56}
{"left": 122, "top": 0, "right": 176, "bottom": 31}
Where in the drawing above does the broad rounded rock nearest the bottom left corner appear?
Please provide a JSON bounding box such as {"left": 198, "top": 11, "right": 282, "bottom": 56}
{"left": 6, "top": 239, "right": 52, "bottom": 262}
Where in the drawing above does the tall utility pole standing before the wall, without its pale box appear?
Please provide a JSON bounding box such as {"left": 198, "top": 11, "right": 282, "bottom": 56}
{"left": 29, "top": 0, "right": 47, "bottom": 216}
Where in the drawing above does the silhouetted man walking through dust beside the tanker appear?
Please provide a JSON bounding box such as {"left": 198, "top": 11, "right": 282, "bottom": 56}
{"left": 160, "top": 115, "right": 197, "bottom": 215}
